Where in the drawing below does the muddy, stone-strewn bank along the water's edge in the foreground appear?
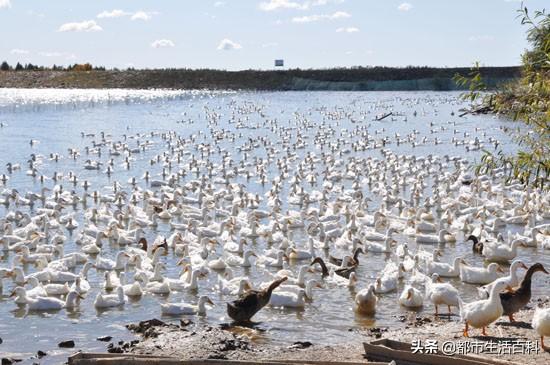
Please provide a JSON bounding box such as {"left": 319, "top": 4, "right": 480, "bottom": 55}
{"left": 125, "top": 309, "right": 550, "bottom": 365}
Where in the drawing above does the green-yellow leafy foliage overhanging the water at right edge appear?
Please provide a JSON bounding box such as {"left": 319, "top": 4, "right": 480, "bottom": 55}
{"left": 462, "top": 4, "right": 550, "bottom": 189}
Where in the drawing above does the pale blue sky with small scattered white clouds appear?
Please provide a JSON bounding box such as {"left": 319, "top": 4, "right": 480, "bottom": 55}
{"left": 0, "top": 0, "right": 548, "bottom": 70}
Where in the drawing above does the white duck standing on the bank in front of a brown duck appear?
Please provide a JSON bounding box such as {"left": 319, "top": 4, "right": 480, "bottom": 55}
{"left": 459, "top": 279, "right": 512, "bottom": 337}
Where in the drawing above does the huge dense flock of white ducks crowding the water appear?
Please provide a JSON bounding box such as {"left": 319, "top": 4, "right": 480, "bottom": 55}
{"left": 0, "top": 94, "right": 550, "bottom": 352}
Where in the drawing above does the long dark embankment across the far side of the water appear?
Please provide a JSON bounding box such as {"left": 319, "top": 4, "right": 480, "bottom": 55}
{"left": 0, "top": 66, "right": 521, "bottom": 91}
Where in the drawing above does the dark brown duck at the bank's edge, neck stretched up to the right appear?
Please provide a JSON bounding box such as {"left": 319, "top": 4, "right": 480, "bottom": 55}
{"left": 227, "top": 277, "right": 287, "bottom": 322}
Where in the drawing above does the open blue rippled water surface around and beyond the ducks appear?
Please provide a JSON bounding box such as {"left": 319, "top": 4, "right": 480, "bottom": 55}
{"left": 0, "top": 89, "right": 550, "bottom": 363}
